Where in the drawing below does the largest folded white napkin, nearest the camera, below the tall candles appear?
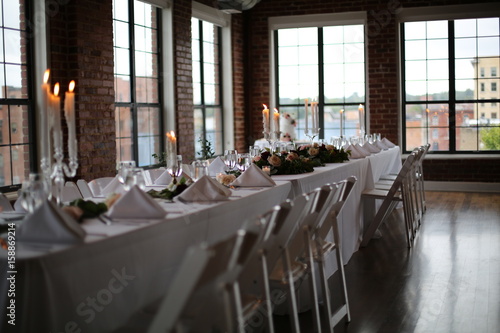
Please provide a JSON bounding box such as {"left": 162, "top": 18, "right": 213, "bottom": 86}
{"left": 16, "top": 200, "right": 86, "bottom": 244}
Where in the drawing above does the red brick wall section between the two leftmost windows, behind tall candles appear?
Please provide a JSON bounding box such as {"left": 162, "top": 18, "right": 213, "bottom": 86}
{"left": 47, "top": 0, "right": 116, "bottom": 179}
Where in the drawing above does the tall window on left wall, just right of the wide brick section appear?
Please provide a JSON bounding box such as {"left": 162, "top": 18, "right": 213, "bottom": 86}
{"left": 113, "top": 0, "right": 164, "bottom": 166}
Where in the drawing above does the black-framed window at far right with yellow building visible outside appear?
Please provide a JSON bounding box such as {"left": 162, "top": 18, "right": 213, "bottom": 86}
{"left": 401, "top": 17, "right": 500, "bottom": 154}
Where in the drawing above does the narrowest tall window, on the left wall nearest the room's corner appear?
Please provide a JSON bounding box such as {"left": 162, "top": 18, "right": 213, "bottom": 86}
{"left": 191, "top": 17, "right": 224, "bottom": 157}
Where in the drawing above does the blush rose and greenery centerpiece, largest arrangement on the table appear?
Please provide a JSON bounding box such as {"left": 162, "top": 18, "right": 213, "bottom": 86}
{"left": 253, "top": 150, "right": 314, "bottom": 175}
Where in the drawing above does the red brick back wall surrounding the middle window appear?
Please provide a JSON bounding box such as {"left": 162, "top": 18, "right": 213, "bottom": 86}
{"left": 246, "top": 0, "right": 500, "bottom": 182}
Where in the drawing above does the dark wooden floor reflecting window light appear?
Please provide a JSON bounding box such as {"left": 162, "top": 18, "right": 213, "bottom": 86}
{"left": 275, "top": 192, "right": 500, "bottom": 333}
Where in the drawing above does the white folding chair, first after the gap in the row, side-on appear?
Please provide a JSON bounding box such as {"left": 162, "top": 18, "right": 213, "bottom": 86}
{"left": 361, "top": 153, "right": 416, "bottom": 247}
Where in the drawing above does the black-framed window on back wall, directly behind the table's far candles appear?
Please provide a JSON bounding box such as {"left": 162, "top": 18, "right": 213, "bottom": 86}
{"left": 274, "top": 19, "right": 366, "bottom": 140}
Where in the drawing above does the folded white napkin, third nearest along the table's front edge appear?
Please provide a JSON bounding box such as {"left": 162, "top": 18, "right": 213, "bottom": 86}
{"left": 177, "top": 176, "right": 231, "bottom": 201}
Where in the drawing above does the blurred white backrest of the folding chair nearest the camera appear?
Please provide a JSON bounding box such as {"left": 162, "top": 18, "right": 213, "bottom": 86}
{"left": 148, "top": 245, "right": 214, "bottom": 333}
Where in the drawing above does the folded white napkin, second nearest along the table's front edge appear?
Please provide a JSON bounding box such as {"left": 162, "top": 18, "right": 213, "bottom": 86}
{"left": 108, "top": 185, "right": 167, "bottom": 219}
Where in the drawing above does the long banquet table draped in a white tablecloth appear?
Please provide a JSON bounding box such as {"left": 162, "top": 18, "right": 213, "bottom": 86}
{"left": 0, "top": 147, "right": 401, "bottom": 332}
